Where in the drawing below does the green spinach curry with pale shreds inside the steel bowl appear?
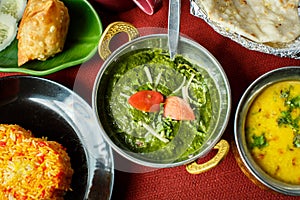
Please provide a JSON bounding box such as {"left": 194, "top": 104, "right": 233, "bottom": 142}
{"left": 104, "top": 49, "right": 212, "bottom": 162}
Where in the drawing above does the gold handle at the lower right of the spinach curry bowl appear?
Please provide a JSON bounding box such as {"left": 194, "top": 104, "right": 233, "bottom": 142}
{"left": 186, "top": 139, "right": 229, "bottom": 174}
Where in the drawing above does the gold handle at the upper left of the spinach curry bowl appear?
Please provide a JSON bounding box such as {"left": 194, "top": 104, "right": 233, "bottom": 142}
{"left": 98, "top": 21, "right": 139, "bottom": 60}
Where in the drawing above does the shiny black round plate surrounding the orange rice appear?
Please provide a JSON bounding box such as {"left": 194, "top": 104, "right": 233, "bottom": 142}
{"left": 0, "top": 76, "right": 114, "bottom": 200}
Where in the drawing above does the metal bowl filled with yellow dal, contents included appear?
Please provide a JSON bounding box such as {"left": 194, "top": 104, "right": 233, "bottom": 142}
{"left": 234, "top": 66, "right": 300, "bottom": 196}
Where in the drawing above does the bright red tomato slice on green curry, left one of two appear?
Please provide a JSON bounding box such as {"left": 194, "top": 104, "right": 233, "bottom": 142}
{"left": 128, "top": 90, "right": 164, "bottom": 112}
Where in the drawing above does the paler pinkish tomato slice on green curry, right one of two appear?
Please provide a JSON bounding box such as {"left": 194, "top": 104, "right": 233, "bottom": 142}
{"left": 164, "top": 96, "right": 195, "bottom": 120}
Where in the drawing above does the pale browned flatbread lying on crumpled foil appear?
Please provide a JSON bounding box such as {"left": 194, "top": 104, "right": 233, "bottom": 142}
{"left": 197, "top": 0, "right": 300, "bottom": 43}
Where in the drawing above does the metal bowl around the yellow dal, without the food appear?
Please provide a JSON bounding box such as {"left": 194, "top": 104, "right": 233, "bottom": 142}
{"left": 234, "top": 66, "right": 300, "bottom": 196}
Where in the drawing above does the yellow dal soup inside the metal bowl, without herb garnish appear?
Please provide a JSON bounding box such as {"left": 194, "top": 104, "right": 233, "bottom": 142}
{"left": 246, "top": 81, "right": 300, "bottom": 184}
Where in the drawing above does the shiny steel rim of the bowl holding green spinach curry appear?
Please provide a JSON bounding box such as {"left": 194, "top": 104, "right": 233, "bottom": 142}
{"left": 92, "top": 33, "right": 232, "bottom": 168}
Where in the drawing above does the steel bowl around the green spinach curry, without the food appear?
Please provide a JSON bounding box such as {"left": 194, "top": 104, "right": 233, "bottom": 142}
{"left": 92, "top": 24, "right": 231, "bottom": 168}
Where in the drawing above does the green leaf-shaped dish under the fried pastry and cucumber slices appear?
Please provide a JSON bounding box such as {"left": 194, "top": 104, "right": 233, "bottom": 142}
{"left": 0, "top": 0, "right": 103, "bottom": 76}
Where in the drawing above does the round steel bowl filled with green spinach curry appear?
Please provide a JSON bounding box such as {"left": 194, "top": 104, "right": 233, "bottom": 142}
{"left": 92, "top": 24, "right": 231, "bottom": 168}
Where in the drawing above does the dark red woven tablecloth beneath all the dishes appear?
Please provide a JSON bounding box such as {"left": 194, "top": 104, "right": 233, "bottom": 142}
{"left": 0, "top": 0, "right": 300, "bottom": 200}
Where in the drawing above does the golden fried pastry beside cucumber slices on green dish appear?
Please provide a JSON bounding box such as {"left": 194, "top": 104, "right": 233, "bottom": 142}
{"left": 17, "top": 0, "right": 70, "bottom": 66}
